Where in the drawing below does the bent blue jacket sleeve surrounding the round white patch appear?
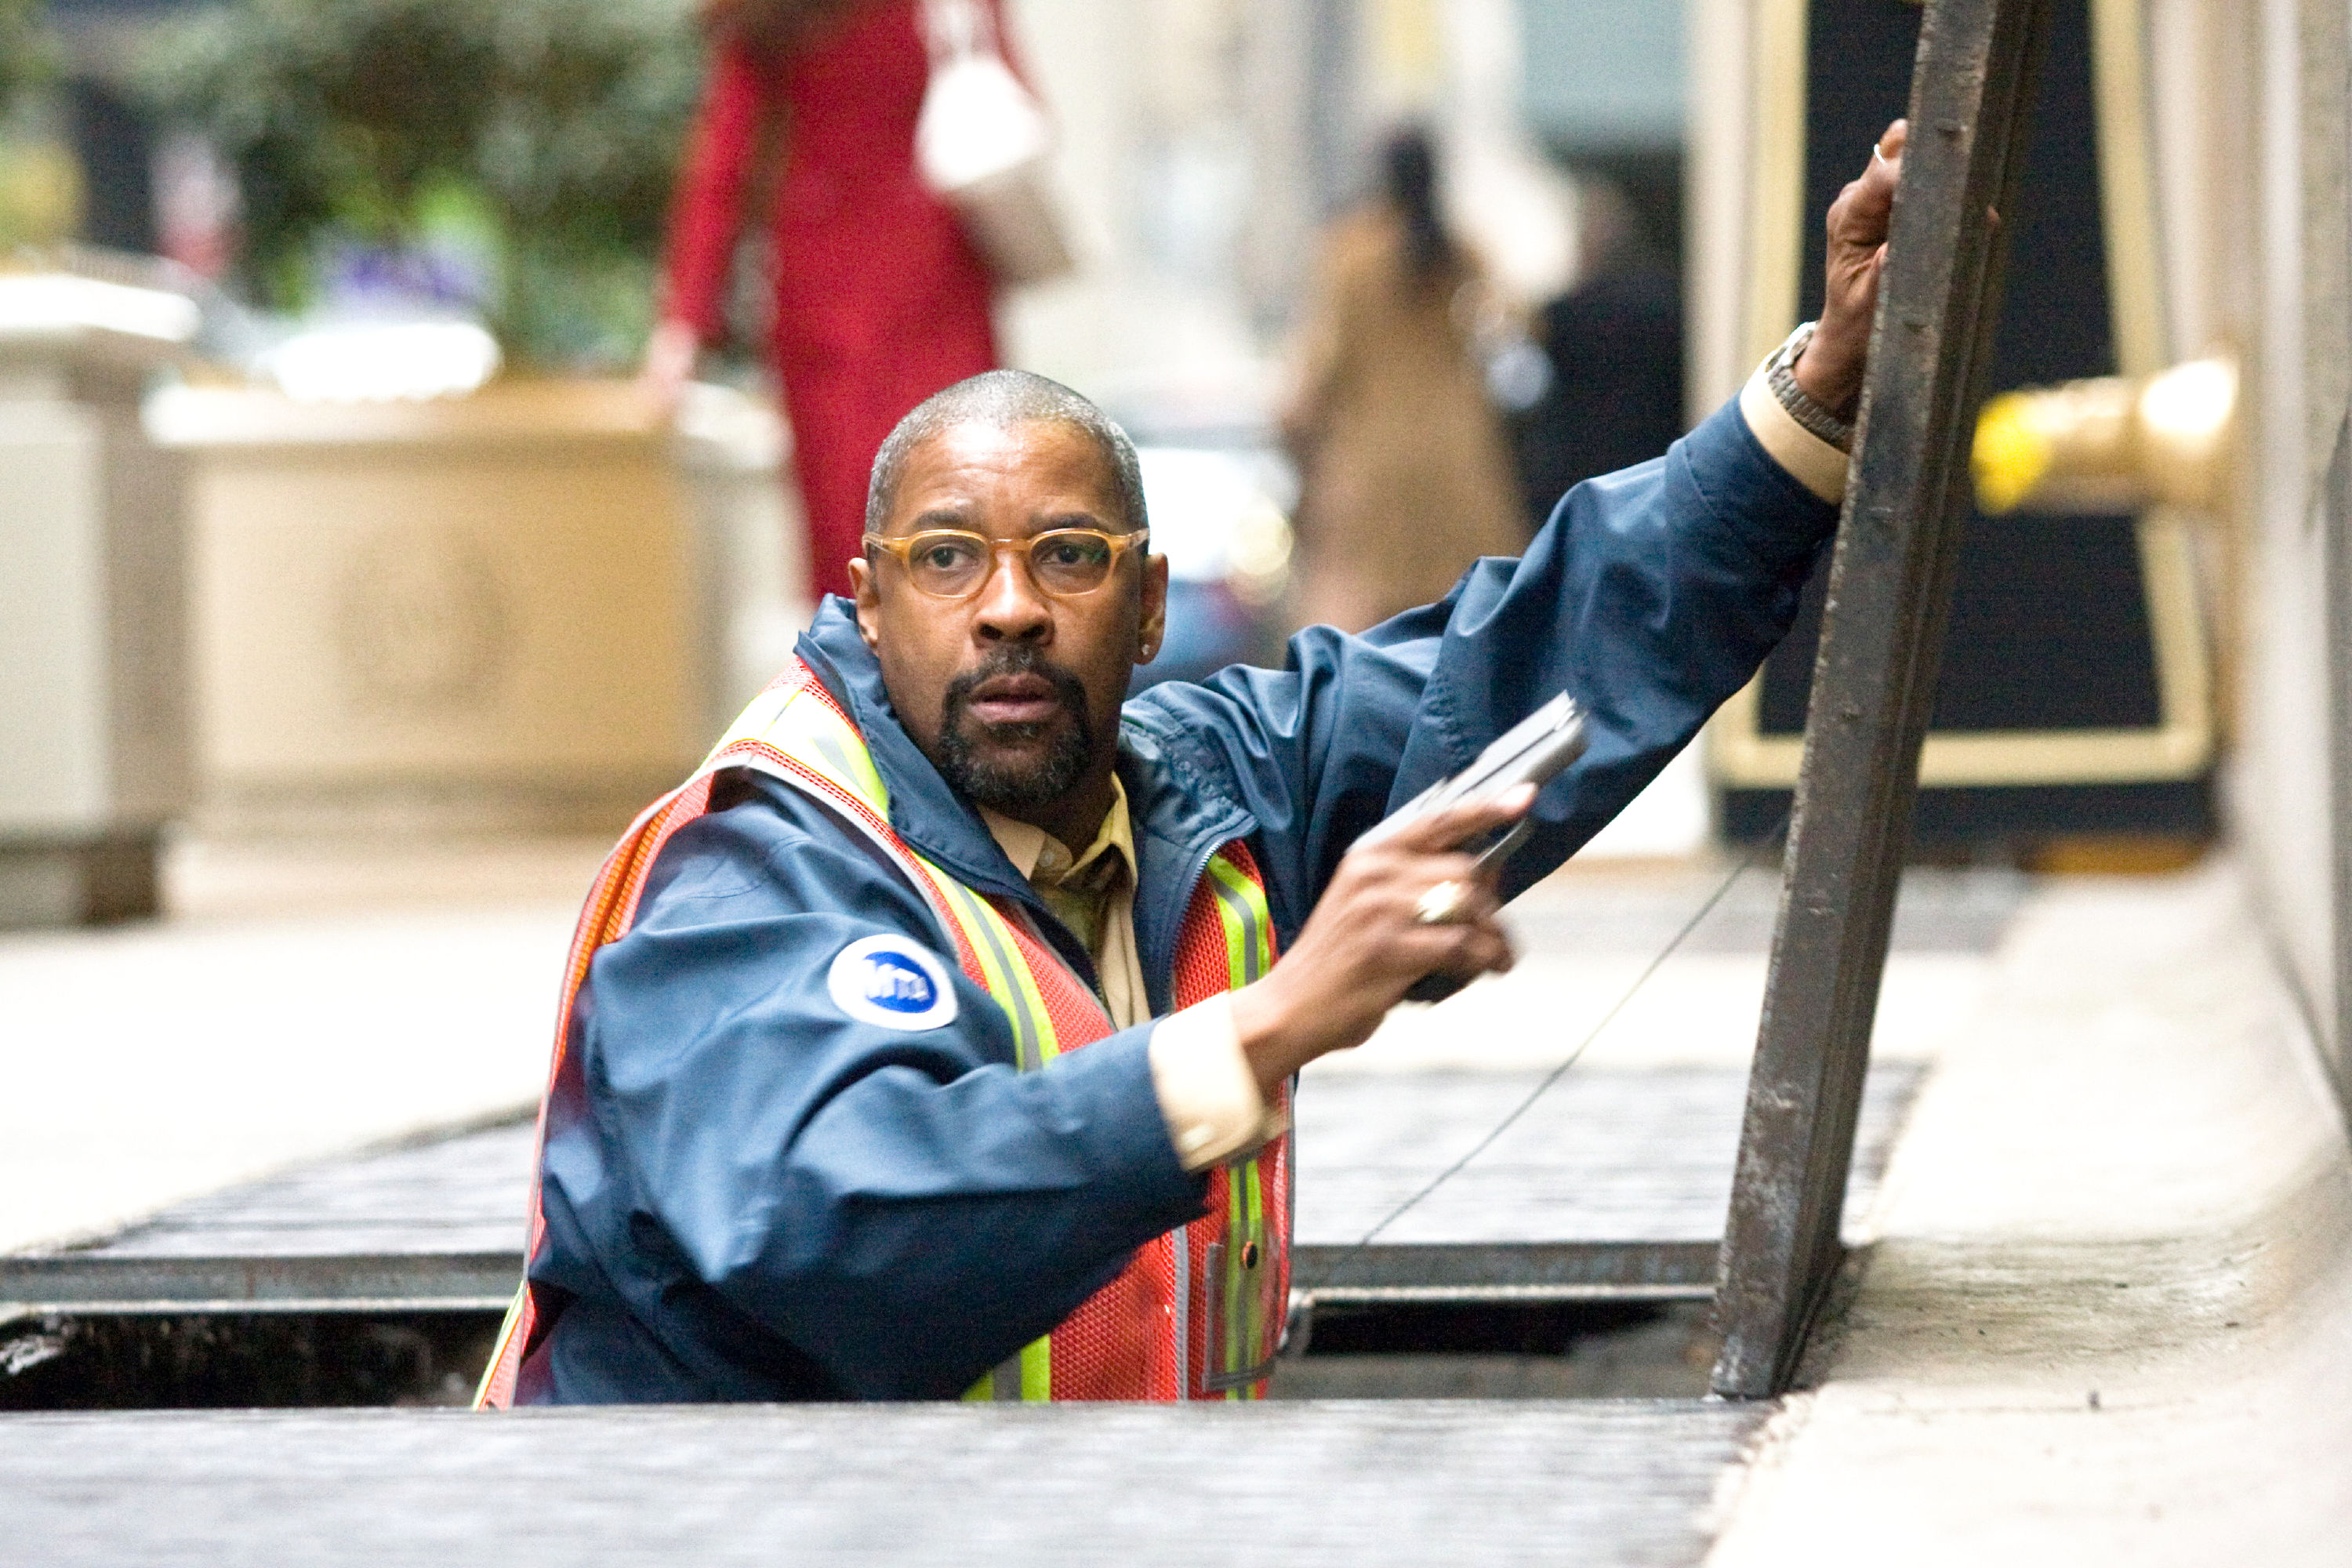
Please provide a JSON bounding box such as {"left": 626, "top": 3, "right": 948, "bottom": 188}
{"left": 534, "top": 783, "right": 1202, "bottom": 1399}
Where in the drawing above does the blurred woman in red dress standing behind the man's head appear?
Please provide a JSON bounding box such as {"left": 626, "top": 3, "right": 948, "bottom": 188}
{"left": 647, "top": 0, "right": 1004, "bottom": 597}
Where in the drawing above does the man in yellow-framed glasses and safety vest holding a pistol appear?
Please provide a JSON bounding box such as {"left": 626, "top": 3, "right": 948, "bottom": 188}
{"left": 485, "top": 125, "right": 1903, "bottom": 1403}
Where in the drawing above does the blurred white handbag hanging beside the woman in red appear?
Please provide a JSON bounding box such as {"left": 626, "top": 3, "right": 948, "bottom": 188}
{"left": 915, "top": 0, "right": 1073, "bottom": 285}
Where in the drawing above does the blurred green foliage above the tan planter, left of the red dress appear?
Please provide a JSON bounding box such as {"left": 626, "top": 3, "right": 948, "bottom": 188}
{"left": 136, "top": 0, "right": 701, "bottom": 362}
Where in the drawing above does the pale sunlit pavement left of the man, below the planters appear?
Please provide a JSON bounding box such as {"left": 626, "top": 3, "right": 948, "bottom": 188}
{"left": 0, "top": 844, "right": 604, "bottom": 1250}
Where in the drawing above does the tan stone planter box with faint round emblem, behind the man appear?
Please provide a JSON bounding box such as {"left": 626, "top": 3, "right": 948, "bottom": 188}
{"left": 148, "top": 381, "right": 710, "bottom": 832}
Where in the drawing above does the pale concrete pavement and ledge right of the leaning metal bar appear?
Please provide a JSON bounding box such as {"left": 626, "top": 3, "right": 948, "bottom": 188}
{"left": 1708, "top": 862, "right": 2352, "bottom": 1568}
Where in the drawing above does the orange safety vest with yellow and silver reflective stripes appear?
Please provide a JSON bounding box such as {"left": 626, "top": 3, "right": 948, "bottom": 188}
{"left": 475, "top": 661, "right": 1291, "bottom": 1408}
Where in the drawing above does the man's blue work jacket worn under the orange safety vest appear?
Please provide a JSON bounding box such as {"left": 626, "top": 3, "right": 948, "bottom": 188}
{"left": 517, "top": 405, "right": 1837, "bottom": 1403}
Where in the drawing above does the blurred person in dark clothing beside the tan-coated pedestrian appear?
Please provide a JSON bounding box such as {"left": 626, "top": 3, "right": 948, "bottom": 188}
{"left": 1510, "top": 179, "right": 1689, "bottom": 532}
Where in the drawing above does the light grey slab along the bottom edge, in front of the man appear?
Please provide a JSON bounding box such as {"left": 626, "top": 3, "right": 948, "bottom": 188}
{"left": 0, "top": 1401, "right": 1769, "bottom": 1568}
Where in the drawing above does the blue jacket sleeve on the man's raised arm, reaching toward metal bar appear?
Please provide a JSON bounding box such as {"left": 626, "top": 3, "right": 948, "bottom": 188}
{"left": 1129, "top": 402, "right": 1837, "bottom": 938}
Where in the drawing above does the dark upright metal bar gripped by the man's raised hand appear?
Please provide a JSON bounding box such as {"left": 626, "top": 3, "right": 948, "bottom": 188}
{"left": 1715, "top": 0, "right": 2049, "bottom": 1399}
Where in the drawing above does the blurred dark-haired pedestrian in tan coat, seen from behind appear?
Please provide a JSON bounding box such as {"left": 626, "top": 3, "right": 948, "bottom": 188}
{"left": 1282, "top": 129, "right": 1526, "bottom": 633}
